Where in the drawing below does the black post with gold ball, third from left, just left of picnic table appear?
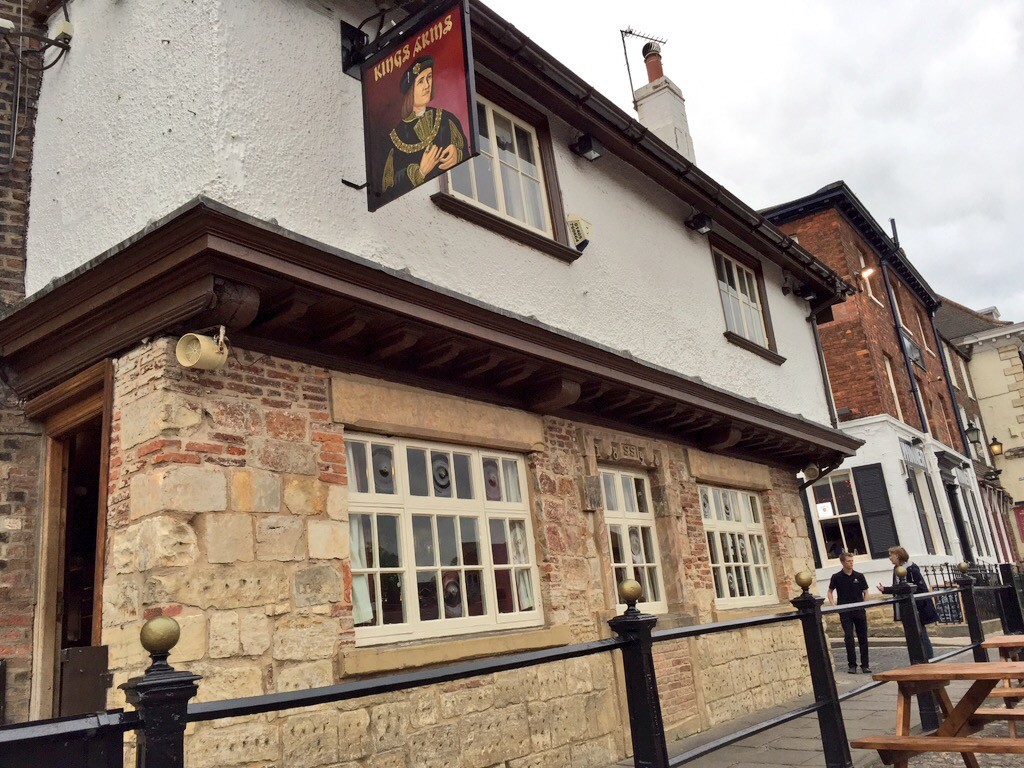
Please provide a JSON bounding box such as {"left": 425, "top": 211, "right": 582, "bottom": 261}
{"left": 790, "top": 570, "right": 853, "bottom": 768}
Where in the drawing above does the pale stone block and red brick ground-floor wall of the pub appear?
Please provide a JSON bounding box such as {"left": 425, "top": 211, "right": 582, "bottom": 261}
{"left": 86, "top": 338, "right": 811, "bottom": 768}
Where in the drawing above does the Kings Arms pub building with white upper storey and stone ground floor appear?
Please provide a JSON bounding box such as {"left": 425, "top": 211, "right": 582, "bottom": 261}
{"left": 0, "top": 0, "right": 860, "bottom": 766}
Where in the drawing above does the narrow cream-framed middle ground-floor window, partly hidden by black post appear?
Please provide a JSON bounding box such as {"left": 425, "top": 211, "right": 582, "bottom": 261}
{"left": 600, "top": 468, "right": 668, "bottom": 612}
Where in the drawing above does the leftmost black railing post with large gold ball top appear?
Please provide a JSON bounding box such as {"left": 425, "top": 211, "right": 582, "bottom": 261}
{"left": 121, "top": 616, "right": 201, "bottom": 768}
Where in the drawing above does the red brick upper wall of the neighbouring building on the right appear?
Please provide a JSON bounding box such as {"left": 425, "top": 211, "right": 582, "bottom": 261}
{"left": 780, "top": 209, "right": 965, "bottom": 451}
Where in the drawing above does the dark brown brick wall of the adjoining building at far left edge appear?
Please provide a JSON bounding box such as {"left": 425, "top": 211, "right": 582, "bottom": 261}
{"left": 0, "top": 0, "right": 43, "bottom": 722}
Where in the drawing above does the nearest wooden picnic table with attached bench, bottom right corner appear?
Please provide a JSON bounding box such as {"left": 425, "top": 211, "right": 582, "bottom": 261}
{"left": 850, "top": 662, "right": 1024, "bottom": 768}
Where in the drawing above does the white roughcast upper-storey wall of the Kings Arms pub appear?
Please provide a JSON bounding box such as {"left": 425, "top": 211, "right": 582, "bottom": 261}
{"left": 28, "top": 0, "right": 827, "bottom": 422}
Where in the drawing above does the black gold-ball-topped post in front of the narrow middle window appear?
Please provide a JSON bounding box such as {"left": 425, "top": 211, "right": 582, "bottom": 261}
{"left": 608, "top": 579, "right": 669, "bottom": 768}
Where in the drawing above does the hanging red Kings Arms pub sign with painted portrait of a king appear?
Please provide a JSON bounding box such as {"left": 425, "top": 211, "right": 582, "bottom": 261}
{"left": 360, "top": 0, "right": 477, "bottom": 211}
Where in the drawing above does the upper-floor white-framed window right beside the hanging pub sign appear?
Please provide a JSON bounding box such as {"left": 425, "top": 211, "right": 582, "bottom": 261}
{"left": 449, "top": 96, "right": 552, "bottom": 236}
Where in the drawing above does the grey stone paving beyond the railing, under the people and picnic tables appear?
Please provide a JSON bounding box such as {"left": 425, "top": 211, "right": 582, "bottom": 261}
{"left": 615, "top": 639, "right": 1024, "bottom": 768}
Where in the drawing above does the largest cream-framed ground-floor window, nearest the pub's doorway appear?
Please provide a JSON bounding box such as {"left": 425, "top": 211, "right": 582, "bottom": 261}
{"left": 345, "top": 435, "right": 542, "bottom": 644}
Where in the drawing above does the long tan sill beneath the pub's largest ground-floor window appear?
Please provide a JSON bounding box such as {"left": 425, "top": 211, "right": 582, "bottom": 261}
{"left": 339, "top": 626, "right": 572, "bottom": 677}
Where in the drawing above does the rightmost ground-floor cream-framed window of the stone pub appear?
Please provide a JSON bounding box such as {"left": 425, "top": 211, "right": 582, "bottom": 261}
{"left": 699, "top": 485, "right": 775, "bottom": 607}
